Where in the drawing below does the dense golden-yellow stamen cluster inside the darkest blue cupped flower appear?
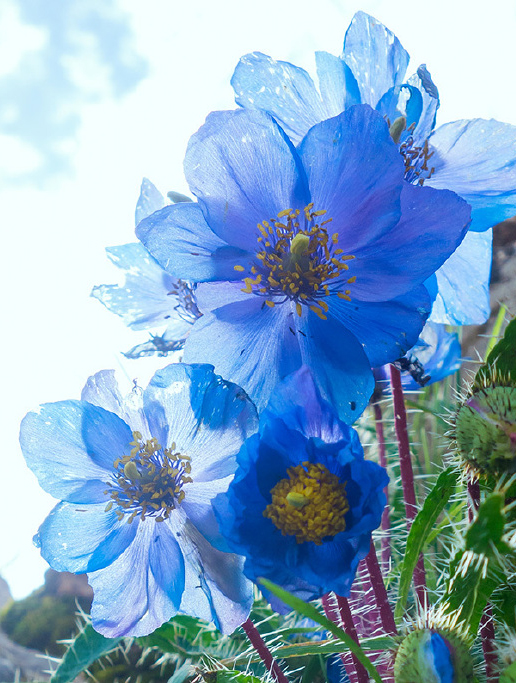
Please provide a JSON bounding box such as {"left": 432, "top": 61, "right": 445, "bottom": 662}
{"left": 263, "top": 462, "right": 349, "bottom": 545}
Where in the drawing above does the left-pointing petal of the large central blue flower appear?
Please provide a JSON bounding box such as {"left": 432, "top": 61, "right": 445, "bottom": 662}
{"left": 136, "top": 203, "right": 251, "bottom": 282}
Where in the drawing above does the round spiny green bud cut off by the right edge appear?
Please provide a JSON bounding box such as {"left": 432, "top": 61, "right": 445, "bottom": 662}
{"left": 455, "top": 386, "right": 516, "bottom": 475}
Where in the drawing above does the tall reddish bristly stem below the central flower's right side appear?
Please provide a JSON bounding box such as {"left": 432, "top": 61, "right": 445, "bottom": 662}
{"left": 390, "top": 365, "right": 426, "bottom": 608}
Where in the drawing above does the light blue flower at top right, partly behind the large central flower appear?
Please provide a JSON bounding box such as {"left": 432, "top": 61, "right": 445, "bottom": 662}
{"left": 232, "top": 12, "right": 504, "bottom": 325}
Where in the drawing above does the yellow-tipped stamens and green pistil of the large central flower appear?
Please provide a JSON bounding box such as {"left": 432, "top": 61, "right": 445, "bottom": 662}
{"left": 235, "top": 204, "right": 356, "bottom": 320}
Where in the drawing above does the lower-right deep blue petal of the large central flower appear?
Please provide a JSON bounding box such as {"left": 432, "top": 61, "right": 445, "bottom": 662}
{"left": 328, "top": 285, "right": 431, "bottom": 367}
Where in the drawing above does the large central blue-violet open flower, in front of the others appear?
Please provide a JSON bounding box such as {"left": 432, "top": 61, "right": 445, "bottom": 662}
{"left": 137, "top": 105, "right": 470, "bottom": 422}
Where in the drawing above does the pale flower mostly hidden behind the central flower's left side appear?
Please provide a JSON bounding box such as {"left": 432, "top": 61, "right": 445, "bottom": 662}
{"left": 91, "top": 178, "right": 200, "bottom": 358}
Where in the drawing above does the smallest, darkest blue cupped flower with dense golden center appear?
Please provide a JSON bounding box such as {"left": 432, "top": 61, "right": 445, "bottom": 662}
{"left": 214, "top": 367, "right": 388, "bottom": 611}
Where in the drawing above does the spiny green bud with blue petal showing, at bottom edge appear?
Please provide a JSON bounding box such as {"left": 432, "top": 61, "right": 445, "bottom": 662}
{"left": 394, "top": 628, "right": 473, "bottom": 683}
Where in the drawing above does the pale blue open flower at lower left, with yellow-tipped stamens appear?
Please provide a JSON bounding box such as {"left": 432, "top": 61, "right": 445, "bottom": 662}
{"left": 20, "top": 364, "right": 256, "bottom": 637}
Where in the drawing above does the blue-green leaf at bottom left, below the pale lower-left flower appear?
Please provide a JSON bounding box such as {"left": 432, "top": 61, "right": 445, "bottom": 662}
{"left": 50, "top": 624, "right": 122, "bottom": 683}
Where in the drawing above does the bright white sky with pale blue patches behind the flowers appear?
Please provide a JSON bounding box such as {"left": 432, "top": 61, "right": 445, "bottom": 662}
{"left": 0, "top": 0, "right": 516, "bottom": 598}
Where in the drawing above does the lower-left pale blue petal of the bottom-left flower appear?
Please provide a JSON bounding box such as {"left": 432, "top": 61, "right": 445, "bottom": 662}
{"left": 36, "top": 496, "right": 138, "bottom": 574}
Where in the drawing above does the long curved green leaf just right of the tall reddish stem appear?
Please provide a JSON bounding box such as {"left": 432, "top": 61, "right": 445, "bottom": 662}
{"left": 394, "top": 467, "right": 457, "bottom": 619}
